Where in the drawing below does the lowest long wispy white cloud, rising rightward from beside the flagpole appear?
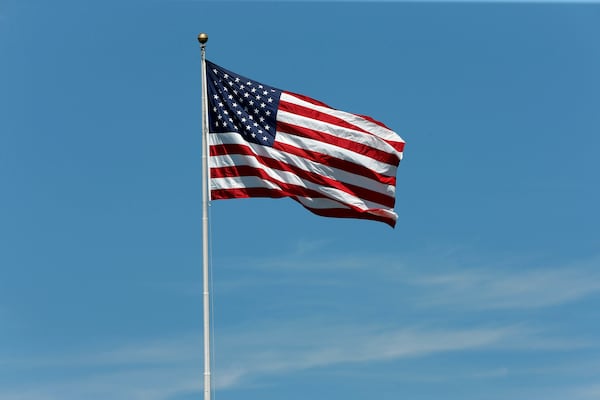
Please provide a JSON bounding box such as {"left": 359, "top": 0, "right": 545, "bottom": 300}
{"left": 214, "top": 326, "right": 520, "bottom": 383}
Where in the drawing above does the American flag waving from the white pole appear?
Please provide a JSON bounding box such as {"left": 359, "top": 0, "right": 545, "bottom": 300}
{"left": 206, "top": 61, "right": 404, "bottom": 227}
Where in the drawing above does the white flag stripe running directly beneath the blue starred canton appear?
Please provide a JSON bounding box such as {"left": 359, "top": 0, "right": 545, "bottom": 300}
{"left": 209, "top": 133, "right": 396, "bottom": 198}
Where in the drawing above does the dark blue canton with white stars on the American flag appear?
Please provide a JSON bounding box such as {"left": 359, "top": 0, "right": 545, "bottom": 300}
{"left": 206, "top": 61, "right": 281, "bottom": 146}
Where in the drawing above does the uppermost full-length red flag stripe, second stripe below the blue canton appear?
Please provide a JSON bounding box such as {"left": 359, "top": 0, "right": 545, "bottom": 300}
{"left": 210, "top": 145, "right": 394, "bottom": 208}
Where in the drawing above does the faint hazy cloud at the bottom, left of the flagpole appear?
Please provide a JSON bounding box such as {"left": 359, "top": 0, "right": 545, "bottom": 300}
{"left": 0, "top": 335, "right": 202, "bottom": 400}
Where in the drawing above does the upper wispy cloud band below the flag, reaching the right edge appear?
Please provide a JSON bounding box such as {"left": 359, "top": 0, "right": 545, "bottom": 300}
{"left": 212, "top": 248, "right": 600, "bottom": 310}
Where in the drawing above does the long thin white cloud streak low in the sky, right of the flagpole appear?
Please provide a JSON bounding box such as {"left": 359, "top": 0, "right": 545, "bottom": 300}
{"left": 217, "top": 323, "right": 575, "bottom": 387}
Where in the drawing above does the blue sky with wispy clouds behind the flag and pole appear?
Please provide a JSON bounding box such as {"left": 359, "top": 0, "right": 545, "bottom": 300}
{"left": 0, "top": 0, "right": 600, "bottom": 400}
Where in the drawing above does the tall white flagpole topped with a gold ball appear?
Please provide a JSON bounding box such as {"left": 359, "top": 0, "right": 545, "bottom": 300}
{"left": 198, "top": 33, "right": 211, "bottom": 400}
